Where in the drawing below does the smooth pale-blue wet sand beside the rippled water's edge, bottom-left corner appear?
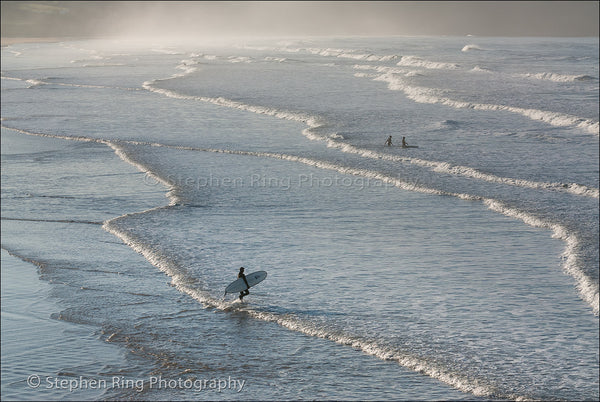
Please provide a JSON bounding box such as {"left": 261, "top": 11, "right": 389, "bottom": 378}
{"left": 1, "top": 249, "right": 130, "bottom": 401}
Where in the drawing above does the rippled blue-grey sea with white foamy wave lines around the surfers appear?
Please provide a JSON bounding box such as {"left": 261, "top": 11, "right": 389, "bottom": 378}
{"left": 2, "top": 37, "right": 599, "bottom": 400}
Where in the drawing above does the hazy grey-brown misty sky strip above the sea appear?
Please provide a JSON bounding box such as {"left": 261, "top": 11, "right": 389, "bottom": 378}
{"left": 1, "top": 0, "right": 599, "bottom": 39}
